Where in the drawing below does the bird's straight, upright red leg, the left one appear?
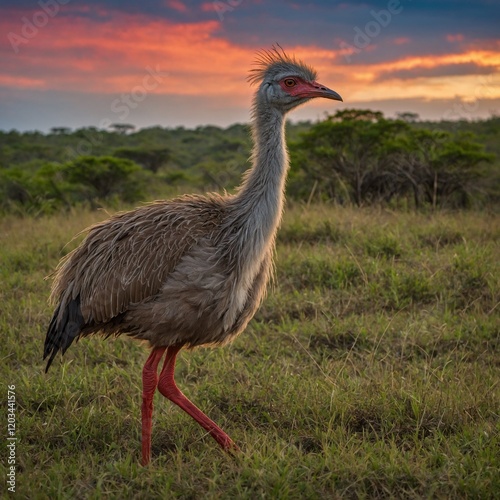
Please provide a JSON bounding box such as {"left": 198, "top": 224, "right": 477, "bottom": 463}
{"left": 141, "top": 347, "right": 166, "bottom": 465}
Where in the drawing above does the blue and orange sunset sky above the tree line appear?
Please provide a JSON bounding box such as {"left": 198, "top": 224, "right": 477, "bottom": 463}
{"left": 0, "top": 0, "right": 500, "bottom": 132}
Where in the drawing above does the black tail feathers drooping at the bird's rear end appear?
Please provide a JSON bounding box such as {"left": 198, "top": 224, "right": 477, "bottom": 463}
{"left": 43, "top": 296, "right": 85, "bottom": 373}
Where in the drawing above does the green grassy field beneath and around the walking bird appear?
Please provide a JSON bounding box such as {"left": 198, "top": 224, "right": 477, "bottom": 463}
{"left": 0, "top": 202, "right": 500, "bottom": 499}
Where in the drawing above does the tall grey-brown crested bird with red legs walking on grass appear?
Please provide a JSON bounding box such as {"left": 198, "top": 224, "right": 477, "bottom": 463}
{"left": 43, "top": 45, "right": 342, "bottom": 466}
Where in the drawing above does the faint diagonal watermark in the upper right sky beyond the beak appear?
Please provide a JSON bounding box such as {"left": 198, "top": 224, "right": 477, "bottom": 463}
{"left": 340, "top": 0, "right": 403, "bottom": 63}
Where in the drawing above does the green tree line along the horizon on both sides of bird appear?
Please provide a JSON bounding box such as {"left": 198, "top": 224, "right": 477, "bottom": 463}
{"left": 0, "top": 109, "right": 500, "bottom": 213}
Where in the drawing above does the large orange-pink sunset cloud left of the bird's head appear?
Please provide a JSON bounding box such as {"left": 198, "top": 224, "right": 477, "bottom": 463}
{"left": 0, "top": 11, "right": 252, "bottom": 99}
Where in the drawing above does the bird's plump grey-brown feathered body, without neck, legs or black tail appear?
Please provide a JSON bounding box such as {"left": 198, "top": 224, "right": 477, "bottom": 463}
{"left": 48, "top": 191, "right": 272, "bottom": 354}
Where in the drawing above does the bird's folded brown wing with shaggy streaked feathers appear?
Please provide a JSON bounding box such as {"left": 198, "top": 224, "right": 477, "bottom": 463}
{"left": 51, "top": 195, "right": 224, "bottom": 324}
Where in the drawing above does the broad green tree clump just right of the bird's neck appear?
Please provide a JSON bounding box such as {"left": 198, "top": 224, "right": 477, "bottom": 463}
{"left": 291, "top": 109, "right": 494, "bottom": 208}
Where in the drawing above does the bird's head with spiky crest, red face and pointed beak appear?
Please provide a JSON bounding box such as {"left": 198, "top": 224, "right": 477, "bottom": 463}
{"left": 248, "top": 46, "right": 342, "bottom": 113}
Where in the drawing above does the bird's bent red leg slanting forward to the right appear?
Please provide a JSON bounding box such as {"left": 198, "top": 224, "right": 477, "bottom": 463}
{"left": 158, "top": 346, "right": 239, "bottom": 451}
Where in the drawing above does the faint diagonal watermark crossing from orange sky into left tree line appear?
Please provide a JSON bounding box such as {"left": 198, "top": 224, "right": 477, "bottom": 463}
{"left": 66, "top": 64, "right": 167, "bottom": 160}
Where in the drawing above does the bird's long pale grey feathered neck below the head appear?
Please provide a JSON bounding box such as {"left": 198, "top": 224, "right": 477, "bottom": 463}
{"left": 233, "top": 101, "right": 288, "bottom": 243}
